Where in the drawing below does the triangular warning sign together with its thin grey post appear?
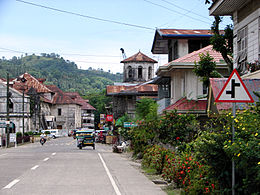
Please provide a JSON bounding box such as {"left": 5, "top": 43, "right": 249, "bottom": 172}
{"left": 215, "top": 69, "right": 254, "bottom": 195}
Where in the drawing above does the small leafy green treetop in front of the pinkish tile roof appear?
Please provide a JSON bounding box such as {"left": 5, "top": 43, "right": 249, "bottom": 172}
{"left": 193, "top": 53, "right": 221, "bottom": 87}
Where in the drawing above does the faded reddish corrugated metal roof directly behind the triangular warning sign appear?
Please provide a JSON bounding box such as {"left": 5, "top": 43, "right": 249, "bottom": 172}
{"left": 210, "top": 78, "right": 260, "bottom": 111}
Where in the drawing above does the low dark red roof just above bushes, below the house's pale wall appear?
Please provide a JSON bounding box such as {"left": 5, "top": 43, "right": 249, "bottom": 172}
{"left": 164, "top": 97, "right": 207, "bottom": 113}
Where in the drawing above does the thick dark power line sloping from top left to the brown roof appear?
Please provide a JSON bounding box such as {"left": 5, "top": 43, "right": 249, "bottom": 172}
{"left": 16, "top": 0, "right": 155, "bottom": 30}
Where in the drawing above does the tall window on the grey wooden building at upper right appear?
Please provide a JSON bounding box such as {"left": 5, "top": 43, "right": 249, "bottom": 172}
{"left": 236, "top": 26, "right": 248, "bottom": 74}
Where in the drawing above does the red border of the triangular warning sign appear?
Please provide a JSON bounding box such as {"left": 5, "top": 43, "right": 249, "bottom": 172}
{"left": 215, "top": 69, "right": 254, "bottom": 103}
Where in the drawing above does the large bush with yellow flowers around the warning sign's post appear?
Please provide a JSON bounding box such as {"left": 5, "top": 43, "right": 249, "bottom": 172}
{"left": 191, "top": 107, "right": 260, "bottom": 194}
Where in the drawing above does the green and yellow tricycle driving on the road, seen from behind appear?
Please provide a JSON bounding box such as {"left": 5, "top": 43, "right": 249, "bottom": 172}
{"left": 76, "top": 130, "right": 95, "bottom": 150}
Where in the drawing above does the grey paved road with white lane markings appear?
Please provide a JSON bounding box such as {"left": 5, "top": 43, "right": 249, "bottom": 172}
{"left": 0, "top": 137, "right": 165, "bottom": 195}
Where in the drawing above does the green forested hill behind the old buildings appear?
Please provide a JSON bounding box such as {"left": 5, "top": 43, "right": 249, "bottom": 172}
{"left": 0, "top": 53, "right": 123, "bottom": 95}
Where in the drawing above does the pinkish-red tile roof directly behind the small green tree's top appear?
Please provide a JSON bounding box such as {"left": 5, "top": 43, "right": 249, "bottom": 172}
{"left": 169, "top": 45, "right": 224, "bottom": 65}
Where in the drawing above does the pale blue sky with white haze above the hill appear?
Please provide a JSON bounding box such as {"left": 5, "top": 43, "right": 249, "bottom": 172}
{"left": 0, "top": 0, "right": 232, "bottom": 73}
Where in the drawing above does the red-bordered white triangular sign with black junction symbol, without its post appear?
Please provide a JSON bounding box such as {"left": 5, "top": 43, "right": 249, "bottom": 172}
{"left": 215, "top": 69, "right": 254, "bottom": 103}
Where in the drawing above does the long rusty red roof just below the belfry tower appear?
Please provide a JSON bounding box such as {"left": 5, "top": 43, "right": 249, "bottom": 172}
{"left": 107, "top": 84, "right": 158, "bottom": 95}
